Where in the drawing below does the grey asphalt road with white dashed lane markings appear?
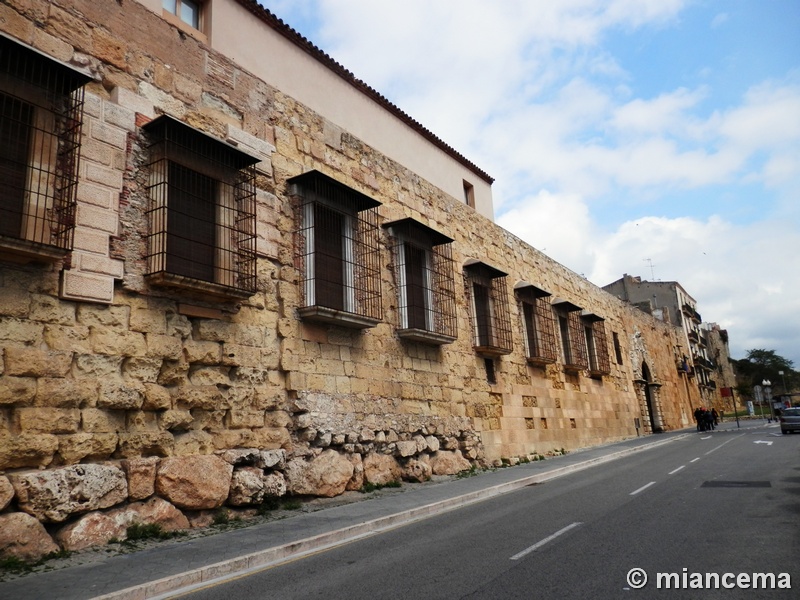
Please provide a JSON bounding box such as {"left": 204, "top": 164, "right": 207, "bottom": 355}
{"left": 184, "top": 425, "right": 800, "bottom": 600}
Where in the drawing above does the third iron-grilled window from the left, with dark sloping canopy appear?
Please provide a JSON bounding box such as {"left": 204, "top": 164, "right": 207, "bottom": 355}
{"left": 289, "top": 171, "right": 381, "bottom": 329}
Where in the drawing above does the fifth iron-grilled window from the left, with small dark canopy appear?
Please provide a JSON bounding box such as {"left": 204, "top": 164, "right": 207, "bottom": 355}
{"left": 464, "top": 262, "right": 512, "bottom": 357}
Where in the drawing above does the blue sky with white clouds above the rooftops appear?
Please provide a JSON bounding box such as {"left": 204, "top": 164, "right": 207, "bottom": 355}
{"left": 261, "top": 0, "right": 800, "bottom": 370}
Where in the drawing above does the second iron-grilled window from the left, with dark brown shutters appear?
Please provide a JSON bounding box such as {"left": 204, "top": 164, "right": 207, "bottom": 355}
{"left": 144, "top": 116, "right": 259, "bottom": 298}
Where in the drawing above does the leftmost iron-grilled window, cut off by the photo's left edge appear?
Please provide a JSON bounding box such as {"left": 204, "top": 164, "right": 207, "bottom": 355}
{"left": 0, "top": 35, "right": 90, "bottom": 259}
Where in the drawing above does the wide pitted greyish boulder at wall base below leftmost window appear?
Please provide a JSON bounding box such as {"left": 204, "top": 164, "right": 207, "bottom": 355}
{"left": 9, "top": 464, "right": 128, "bottom": 523}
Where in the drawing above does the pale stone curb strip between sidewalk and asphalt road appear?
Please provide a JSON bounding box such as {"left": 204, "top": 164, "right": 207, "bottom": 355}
{"left": 93, "top": 432, "right": 694, "bottom": 600}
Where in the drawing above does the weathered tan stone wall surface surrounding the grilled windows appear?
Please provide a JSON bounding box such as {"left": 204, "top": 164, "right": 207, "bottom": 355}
{"left": 0, "top": 0, "right": 696, "bottom": 558}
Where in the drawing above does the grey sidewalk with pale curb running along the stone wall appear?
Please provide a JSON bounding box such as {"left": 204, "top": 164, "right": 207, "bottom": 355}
{"left": 0, "top": 420, "right": 767, "bottom": 600}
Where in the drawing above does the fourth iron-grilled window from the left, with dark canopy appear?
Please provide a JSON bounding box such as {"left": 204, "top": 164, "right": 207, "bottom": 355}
{"left": 384, "top": 219, "right": 457, "bottom": 344}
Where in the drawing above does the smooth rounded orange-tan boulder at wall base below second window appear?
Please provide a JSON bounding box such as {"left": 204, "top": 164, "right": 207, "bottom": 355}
{"left": 156, "top": 456, "right": 233, "bottom": 510}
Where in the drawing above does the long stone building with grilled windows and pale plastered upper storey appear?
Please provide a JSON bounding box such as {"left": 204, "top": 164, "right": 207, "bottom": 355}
{"left": 0, "top": 0, "right": 713, "bottom": 554}
